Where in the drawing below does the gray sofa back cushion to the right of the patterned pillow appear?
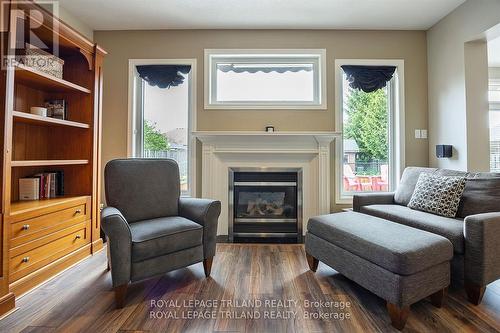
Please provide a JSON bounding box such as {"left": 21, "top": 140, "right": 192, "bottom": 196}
{"left": 457, "top": 173, "right": 500, "bottom": 218}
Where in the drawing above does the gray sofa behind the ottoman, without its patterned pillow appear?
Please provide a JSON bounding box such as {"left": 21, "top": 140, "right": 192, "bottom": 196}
{"left": 353, "top": 167, "right": 500, "bottom": 304}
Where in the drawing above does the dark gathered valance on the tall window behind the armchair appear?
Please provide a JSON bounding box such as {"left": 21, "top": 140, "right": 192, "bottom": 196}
{"left": 136, "top": 65, "right": 191, "bottom": 89}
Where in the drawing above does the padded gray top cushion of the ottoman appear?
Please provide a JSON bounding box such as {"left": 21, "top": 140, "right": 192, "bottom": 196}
{"left": 307, "top": 212, "right": 453, "bottom": 275}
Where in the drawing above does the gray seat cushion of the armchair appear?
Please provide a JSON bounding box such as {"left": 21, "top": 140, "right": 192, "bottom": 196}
{"left": 130, "top": 216, "right": 203, "bottom": 262}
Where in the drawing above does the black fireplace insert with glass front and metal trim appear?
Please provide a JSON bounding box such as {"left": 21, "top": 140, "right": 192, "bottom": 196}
{"left": 228, "top": 168, "right": 302, "bottom": 242}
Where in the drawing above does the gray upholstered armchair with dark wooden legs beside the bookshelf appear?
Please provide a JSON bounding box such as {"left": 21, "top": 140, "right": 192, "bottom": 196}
{"left": 101, "top": 159, "right": 220, "bottom": 308}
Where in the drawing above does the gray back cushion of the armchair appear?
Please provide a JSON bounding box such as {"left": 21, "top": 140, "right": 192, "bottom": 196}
{"left": 104, "top": 158, "right": 180, "bottom": 223}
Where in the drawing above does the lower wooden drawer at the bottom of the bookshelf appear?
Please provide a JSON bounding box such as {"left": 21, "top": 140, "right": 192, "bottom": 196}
{"left": 10, "top": 220, "right": 91, "bottom": 282}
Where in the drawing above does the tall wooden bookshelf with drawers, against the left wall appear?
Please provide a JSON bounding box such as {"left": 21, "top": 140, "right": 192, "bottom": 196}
{"left": 0, "top": 1, "right": 105, "bottom": 315}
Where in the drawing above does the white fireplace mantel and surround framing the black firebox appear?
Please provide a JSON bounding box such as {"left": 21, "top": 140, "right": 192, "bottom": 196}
{"left": 193, "top": 131, "right": 340, "bottom": 235}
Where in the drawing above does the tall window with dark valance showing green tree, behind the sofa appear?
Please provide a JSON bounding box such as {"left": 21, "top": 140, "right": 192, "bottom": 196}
{"left": 336, "top": 60, "right": 404, "bottom": 203}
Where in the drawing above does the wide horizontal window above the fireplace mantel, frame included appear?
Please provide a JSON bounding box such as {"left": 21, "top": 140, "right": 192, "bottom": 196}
{"left": 205, "top": 50, "right": 326, "bottom": 109}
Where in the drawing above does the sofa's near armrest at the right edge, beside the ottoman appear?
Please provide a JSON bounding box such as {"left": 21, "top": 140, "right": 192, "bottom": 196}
{"left": 464, "top": 212, "right": 500, "bottom": 286}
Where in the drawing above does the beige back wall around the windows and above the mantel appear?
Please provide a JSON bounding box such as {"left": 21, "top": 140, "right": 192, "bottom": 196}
{"left": 94, "top": 30, "right": 429, "bottom": 209}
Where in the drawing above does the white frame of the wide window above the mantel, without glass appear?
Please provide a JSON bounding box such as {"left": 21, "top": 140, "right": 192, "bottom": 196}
{"left": 204, "top": 49, "right": 327, "bottom": 110}
